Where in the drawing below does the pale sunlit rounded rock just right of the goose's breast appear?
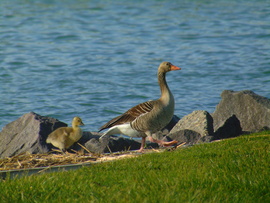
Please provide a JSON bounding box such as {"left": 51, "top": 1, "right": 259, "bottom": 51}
{"left": 170, "top": 110, "right": 214, "bottom": 137}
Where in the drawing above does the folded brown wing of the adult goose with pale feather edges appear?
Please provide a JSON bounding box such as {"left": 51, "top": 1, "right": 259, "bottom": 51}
{"left": 99, "top": 101, "right": 156, "bottom": 131}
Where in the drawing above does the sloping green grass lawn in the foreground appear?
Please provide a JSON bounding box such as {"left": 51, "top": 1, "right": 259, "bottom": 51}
{"left": 0, "top": 132, "right": 270, "bottom": 203}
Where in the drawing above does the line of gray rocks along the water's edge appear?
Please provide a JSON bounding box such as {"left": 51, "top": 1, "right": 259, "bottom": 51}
{"left": 0, "top": 90, "right": 270, "bottom": 158}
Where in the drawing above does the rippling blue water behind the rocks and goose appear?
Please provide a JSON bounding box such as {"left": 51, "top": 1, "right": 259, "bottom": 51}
{"left": 0, "top": 0, "right": 270, "bottom": 131}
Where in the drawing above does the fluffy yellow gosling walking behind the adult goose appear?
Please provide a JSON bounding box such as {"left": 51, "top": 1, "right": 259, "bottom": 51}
{"left": 46, "top": 117, "right": 84, "bottom": 152}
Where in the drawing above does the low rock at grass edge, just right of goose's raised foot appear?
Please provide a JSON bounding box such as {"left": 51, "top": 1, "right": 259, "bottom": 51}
{"left": 167, "top": 129, "right": 201, "bottom": 144}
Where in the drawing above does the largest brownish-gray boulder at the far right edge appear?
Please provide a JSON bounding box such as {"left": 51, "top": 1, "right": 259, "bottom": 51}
{"left": 212, "top": 90, "right": 270, "bottom": 132}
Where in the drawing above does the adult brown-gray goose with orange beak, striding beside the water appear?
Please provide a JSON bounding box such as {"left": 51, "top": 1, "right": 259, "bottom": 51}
{"left": 100, "top": 62, "right": 181, "bottom": 152}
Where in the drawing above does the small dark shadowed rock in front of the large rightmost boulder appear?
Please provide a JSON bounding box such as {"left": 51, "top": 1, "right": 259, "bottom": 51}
{"left": 213, "top": 115, "right": 242, "bottom": 140}
